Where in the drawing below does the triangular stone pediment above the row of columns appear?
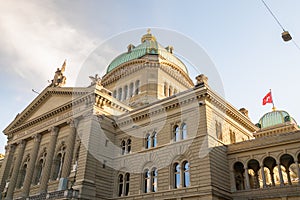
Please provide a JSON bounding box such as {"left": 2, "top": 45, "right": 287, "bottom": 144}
{"left": 3, "top": 87, "right": 88, "bottom": 134}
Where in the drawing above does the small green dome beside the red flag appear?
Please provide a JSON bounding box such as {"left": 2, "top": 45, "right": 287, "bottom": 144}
{"left": 256, "top": 110, "right": 297, "bottom": 128}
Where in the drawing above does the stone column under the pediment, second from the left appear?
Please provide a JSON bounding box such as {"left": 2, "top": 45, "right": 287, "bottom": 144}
{"left": 5, "top": 140, "right": 26, "bottom": 200}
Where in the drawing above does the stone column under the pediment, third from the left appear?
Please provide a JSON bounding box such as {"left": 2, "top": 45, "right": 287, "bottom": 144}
{"left": 23, "top": 134, "right": 41, "bottom": 197}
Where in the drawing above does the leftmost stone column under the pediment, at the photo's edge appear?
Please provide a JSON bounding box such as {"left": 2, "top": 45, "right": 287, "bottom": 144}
{"left": 0, "top": 144, "right": 15, "bottom": 196}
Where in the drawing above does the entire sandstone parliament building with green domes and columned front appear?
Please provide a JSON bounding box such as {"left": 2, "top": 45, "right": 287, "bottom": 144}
{"left": 0, "top": 31, "right": 300, "bottom": 200}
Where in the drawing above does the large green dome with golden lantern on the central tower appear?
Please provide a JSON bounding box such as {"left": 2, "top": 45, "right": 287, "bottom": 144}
{"left": 106, "top": 32, "right": 188, "bottom": 73}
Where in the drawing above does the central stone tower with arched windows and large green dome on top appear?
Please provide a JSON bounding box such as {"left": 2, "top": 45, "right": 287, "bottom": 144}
{"left": 102, "top": 29, "right": 193, "bottom": 107}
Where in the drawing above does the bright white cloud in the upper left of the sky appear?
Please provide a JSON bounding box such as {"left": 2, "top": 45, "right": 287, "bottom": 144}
{"left": 0, "top": 1, "right": 95, "bottom": 86}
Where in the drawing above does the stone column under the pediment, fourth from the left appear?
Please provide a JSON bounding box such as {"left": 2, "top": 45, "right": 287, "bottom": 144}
{"left": 40, "top": 127, "right": 59, "bottom": 193}
